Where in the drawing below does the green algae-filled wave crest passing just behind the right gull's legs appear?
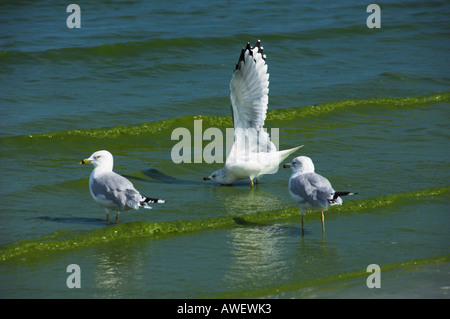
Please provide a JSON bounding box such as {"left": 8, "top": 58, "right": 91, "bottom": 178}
{"left": 0, "top": 186, "right": 450, "bottom": 262}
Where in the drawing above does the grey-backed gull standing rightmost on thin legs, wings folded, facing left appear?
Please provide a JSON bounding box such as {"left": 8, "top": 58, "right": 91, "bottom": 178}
{"left": 283, "top": 156, "right": 358, "bottom": 234}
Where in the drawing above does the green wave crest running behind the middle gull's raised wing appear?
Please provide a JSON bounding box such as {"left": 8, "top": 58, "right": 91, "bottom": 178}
{"left": 0, "top": 92, "right": 450, "bottom": 145}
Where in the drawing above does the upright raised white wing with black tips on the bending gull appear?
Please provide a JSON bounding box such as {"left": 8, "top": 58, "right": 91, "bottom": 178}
{"left": 230, "top": 40, "right": 269, "bottom": 131}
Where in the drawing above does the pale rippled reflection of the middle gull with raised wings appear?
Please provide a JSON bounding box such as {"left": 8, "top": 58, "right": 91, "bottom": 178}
{"left": 220, "top": 186, "right": 289, "bottom": 288}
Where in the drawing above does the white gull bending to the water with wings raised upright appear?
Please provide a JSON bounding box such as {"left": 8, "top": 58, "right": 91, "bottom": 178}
{"left": 203, "top": 40, "right": 303, "bottom": 187}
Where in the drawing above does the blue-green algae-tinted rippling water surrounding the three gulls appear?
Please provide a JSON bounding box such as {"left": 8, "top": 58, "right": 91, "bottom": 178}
{"left": 0, "top": 0, "right": 450, "bottom": 298}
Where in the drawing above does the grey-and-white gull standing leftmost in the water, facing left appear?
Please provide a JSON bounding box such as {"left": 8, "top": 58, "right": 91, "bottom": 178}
{"left": 80, "top": 151, "right": 165, "bottom": 225}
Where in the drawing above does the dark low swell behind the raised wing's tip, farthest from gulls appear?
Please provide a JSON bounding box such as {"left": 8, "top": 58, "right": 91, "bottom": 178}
{"left": 0, "top": 18, "right": 428, "bottom": 65}
